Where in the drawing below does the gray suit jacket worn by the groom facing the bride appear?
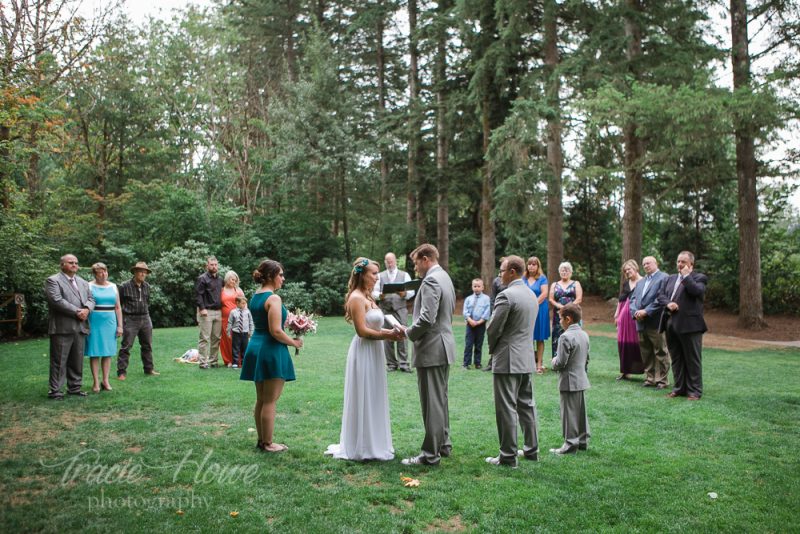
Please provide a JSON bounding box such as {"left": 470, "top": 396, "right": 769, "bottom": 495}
{"left": 407, "top": 265, "right": 456, "bottom": 367}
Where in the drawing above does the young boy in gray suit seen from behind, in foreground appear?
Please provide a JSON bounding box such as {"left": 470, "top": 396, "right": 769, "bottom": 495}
{"left": 550, "top": 304, "right": 590, "bottom": 454}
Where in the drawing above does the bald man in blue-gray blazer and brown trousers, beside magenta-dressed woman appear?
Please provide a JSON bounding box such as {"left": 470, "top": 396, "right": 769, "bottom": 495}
{"left": 631, "top": 256, "right": 670, "bottom": 389}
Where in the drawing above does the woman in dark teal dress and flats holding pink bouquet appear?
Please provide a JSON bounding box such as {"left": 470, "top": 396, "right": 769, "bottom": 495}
{"left": 239, "top": 260, "right": 303, "bottom": 452}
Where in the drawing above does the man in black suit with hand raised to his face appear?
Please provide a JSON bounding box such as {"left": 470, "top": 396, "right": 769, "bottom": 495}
{"left": 658, "top": 250, "right": 708, "bottom": 400}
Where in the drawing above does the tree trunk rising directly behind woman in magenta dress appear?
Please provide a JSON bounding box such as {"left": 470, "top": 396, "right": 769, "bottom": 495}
{"left": 622, "top": 0, "right": 644, "bottom": 268}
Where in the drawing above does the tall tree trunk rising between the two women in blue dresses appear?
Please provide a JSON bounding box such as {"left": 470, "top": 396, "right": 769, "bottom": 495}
{"left": 544, "top": 0, "right": 564, "bottom": 281}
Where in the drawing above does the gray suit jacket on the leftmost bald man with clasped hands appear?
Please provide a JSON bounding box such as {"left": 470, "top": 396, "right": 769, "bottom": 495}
{"left": 44, "top": 273, "right": 94, "bottom": 334}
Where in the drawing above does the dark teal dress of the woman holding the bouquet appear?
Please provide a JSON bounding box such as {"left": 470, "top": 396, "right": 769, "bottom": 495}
{"left": 239, "top": 291, "right": 295, "bottom": 382}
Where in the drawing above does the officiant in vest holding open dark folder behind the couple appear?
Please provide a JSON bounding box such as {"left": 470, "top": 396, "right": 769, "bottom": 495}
{"left": 372, "top": 252, "right": 415, "bottom": 373}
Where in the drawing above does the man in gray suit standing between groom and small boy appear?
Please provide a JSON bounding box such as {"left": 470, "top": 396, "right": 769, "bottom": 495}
{"left": 486, "top": 256, "right": 539, "bottom": 467}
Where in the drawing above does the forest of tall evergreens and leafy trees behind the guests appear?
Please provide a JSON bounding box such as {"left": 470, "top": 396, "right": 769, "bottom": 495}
{"left": 0, "top": 0, "right": 800, "bottom": 333}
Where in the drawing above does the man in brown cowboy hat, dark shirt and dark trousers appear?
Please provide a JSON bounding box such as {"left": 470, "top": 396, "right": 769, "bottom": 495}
{"left": 117, "top": 261, "right": 160, "bottom": 380}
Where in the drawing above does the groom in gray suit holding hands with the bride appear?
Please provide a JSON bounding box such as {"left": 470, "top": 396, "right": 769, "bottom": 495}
{"left": 402, "top": 244, "right": 456, "bottom": 465}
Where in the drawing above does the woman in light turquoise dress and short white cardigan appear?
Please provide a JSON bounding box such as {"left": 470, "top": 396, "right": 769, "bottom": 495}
{"left": 84, "top": 262, "right": 122, "bottom": 393}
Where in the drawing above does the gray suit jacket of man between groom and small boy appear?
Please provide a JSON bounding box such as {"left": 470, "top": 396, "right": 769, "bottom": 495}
{"left": 486, "top": 279, "right": 539, "bottom": 374}
